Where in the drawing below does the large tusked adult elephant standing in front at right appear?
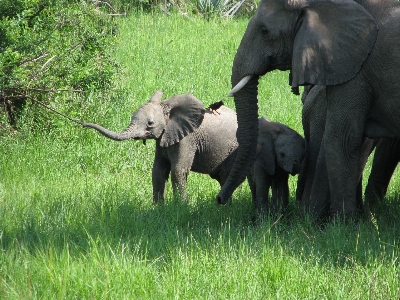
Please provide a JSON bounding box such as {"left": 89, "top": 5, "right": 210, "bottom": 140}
{"left": 216, "top": 0, "right": 400, "bottom": 216}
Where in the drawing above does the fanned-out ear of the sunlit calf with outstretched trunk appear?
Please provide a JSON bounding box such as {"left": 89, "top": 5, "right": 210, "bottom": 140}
{"left": 160, "top": 94, "right": 205, "bottom": 147}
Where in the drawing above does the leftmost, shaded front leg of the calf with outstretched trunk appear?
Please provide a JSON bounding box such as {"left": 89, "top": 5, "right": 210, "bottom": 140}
{"left": 152, "top": 148, "right": 171, "bottom": 203}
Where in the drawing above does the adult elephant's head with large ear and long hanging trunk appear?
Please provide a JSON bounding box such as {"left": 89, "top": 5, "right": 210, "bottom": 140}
{"left": 216, "top": 0, "right": 377, "bottom": 204}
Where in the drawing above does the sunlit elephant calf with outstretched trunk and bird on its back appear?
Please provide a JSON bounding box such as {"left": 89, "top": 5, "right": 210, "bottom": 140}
{"left": 83, "top": 91, "right": 238, "bottom": 202}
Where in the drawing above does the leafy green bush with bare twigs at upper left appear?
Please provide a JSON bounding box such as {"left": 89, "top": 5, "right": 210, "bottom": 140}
{"left": 0, "top": 0, "right": 117, "bottom": 128}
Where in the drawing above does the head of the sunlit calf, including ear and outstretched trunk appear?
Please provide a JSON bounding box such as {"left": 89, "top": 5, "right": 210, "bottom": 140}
{"left": 82, "top": 91, "right": 205, "bottom": 147}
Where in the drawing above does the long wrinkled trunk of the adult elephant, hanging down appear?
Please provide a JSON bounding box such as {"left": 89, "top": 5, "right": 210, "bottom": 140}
{"left": 216, "top": 75, "right": 258, "bottom": 204}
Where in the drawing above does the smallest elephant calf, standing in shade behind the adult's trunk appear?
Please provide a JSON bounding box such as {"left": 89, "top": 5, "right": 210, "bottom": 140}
{"left": 248, "top": 118, "right": 305, "bottom": 214}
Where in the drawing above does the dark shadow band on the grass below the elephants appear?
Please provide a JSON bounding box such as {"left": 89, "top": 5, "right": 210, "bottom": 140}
{"left": 0, "top": 192, "right": 400, "bottom": 265}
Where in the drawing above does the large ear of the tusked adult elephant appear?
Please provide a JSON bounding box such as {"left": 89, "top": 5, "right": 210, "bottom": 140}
{"left": 286, "top": 0, "right": 378, "bottom": 89}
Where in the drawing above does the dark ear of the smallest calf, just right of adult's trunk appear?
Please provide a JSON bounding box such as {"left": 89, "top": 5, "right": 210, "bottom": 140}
{"left": 256, "top": 118, "right": 279, "bottom": 176}
